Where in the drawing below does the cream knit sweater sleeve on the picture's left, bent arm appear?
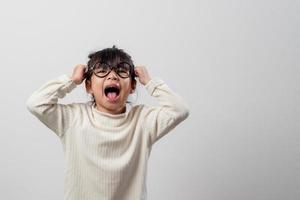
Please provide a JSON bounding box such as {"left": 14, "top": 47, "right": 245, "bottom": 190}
{"left": 26, "top": 75, "right": 76, "bottom": 137}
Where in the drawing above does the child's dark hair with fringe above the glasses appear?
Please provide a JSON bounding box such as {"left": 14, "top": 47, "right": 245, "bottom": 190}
{"left": 85, "top": 45, "right": 136, "bottom": 103}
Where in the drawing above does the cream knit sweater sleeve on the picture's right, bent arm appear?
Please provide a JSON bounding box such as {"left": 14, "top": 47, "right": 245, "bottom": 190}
{"left": 144, "top": 77, "right": 189, "bottom": 145}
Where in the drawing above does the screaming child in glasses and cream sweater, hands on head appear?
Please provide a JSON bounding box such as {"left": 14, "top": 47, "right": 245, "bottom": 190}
{"left": 26, "top": 46, "right": 189, "bottom": 200}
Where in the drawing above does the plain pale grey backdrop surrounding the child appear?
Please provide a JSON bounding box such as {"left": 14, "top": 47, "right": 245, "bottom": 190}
{"left": 0, "top": 0, "right": 300, "bottom": 200}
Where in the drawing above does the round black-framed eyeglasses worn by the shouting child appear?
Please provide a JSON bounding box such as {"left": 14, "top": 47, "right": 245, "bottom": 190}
{"left": 93, "top": 62, "right": 133, "bottom": 78}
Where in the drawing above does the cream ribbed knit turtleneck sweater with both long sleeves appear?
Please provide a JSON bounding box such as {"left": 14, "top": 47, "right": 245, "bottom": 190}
{"left": 26, "top": 74, "right": 189, "bottom": 200}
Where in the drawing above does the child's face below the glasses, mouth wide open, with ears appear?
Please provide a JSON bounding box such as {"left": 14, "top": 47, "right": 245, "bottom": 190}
{"left": 86, "top": 67, "right": 135, "bottom": 114}
